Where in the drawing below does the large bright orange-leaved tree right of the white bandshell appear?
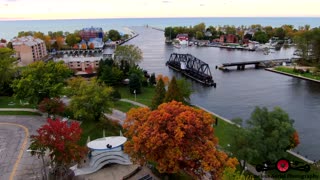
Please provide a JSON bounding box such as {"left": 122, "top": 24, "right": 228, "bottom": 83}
{"left": 123, "top": 101, "right": 237, "bottom": 179}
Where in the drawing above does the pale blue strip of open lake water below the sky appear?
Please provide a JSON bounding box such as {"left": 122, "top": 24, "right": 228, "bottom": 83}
{"left": 0, "top": 17, "right": 320, "bottom": 40}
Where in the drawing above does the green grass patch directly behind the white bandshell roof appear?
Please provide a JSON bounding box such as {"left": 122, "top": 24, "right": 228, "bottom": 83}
{"left": 79, "top": 120, "right": 122, "bottom": 146}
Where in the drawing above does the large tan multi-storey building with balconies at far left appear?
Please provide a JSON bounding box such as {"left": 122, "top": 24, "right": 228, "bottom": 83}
{"left": 12, "top": 36, "right": 48, "bottom": 65}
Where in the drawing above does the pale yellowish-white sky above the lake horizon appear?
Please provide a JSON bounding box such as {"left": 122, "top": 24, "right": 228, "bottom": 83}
{"left": 0, "top": 0, "right": 320, "bottom": 20}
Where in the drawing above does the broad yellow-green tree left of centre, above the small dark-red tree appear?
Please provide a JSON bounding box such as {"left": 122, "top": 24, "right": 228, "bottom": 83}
{"left": 12, "top": 61, "right": 72, "bottom": 104}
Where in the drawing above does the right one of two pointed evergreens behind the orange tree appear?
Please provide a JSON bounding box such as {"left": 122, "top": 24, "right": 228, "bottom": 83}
{"left": 164, "top": 76, "right": 183, "bottom": 102}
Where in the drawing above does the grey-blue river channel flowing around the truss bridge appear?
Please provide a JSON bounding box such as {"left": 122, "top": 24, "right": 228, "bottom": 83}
{"left": 128, "top": 27, "right": 320, "bottom": 160}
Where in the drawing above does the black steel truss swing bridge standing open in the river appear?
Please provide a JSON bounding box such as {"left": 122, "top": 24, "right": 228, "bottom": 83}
{"left": 166, "top": 53, "right": 216, "bottom": 87}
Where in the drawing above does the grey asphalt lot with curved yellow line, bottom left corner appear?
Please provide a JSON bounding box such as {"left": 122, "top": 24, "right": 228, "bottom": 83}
{"left": 0, "top": 116, "right": 45, "bottom": 180}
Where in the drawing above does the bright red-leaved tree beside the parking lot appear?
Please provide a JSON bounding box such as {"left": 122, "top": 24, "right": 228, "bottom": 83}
{"left": 30, "top": 119, "right": 87, "bottom": 167}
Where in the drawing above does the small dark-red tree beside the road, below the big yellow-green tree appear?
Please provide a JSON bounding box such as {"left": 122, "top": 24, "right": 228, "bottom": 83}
{"left": 38, "top": 98, "right": 65, "bottom": 115}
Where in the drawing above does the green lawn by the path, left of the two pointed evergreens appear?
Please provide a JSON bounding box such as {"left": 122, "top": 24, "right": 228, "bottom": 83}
{"left": 115, "top": 86, "right": 155, "bottom": 106}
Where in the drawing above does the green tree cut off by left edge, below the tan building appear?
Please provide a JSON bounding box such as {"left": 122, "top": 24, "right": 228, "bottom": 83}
{"left": 0, "top": 48, "right": 17, "bottom": 85}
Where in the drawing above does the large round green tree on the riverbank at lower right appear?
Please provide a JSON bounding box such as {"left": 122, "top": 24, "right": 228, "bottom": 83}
{"left": 247, "top": 107, "right": 295, "bottom": 162}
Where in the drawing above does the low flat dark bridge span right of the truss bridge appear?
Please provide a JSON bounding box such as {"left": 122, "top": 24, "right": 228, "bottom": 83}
{"left": 219, "top": 58, "right": 297, "bottom": 70}
